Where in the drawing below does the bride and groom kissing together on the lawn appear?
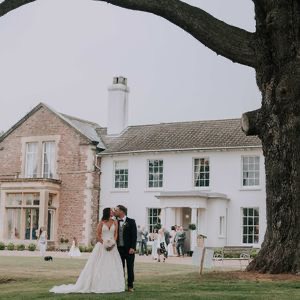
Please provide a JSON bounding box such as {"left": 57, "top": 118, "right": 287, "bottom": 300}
{"left": 50, "top": 205, "right": 137, "bottom": 294}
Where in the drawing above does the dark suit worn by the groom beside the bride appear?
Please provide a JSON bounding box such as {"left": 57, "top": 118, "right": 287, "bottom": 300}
{"left": 117, "top": 217, "right": 137, "bottom": 288}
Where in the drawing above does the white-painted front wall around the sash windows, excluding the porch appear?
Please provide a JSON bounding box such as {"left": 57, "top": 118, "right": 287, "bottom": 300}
{"left": 100, "top": 148, "right": 266, "bottom": 246}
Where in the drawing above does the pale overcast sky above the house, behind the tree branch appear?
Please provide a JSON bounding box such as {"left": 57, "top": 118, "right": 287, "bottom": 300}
{"left": 0, "top": 0, "right": 260, "bottom": 130}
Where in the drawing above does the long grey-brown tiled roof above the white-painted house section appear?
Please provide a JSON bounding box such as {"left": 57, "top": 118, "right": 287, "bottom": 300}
{"left": 97, "top": 119, "right": 261, "bottom": 154}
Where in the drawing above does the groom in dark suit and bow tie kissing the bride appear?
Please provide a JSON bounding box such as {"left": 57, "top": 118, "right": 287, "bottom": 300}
{"left": 115, "top": 205, "right": 137, "bottom": 292}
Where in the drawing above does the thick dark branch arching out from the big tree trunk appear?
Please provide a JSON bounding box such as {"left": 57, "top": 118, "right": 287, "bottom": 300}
{"left": 94, "top": 0, "right": 256, "bottom": 68}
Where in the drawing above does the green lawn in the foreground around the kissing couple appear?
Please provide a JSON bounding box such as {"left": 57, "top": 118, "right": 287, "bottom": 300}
{"left": 0, "top": 256, "right": 300, "bottom": 300}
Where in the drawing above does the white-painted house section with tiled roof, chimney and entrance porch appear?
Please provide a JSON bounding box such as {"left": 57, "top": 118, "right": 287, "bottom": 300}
{"left": 98, "top": 77, "right": 266, "bottom": 249}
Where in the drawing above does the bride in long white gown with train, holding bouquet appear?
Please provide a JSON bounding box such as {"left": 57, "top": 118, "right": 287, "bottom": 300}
{"left": 50, "top": 207, "right": 125, "bottom": 294}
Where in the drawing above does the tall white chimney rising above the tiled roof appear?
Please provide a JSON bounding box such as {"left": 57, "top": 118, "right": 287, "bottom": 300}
{"left": 107, "top": 76, "right": 129, "bottom": 135}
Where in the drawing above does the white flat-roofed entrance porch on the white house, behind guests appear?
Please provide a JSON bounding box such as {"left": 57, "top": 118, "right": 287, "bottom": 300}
{"left": 156, "top": 191, "right": 229, "bottom": 251}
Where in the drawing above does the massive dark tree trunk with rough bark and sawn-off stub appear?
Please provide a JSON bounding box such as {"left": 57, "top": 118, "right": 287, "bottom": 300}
{"left": 243, "top": 0, "right": 300, "bottom": 273}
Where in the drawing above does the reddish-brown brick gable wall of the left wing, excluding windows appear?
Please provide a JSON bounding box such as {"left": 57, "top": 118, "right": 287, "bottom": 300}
{"left": 0, "top": 106, "right": 100, "bottom": 243}
